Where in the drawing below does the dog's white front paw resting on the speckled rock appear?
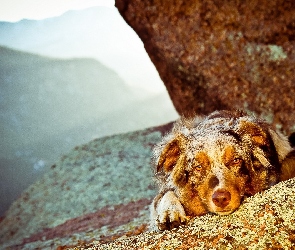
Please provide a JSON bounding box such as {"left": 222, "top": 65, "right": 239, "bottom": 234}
{"left": 156, "top": 191, "right": 187, "bottom": 230}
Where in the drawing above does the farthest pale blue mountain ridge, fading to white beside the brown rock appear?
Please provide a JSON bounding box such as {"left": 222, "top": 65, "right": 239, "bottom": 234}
{"left": 0, "top": 7, "right": 164, "bottom": 93}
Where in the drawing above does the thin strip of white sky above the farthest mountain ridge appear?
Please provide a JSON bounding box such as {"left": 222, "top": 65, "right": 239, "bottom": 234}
{"left": 0, "top": 0, "right": 115, "bottom": 22}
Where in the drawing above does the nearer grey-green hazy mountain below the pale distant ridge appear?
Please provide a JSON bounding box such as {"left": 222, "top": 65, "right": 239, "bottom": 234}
{"left": 0, "top": 47, "right": 177, "bottom": 215}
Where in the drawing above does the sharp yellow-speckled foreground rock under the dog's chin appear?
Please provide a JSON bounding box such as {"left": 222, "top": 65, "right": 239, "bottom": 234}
{"left": 71, "top": 179, "right": 295, "bottom": 250}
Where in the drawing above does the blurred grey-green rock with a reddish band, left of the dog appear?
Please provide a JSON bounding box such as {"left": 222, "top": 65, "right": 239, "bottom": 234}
{"left": 0, "top": 124, "right": 172, "bottom": 249}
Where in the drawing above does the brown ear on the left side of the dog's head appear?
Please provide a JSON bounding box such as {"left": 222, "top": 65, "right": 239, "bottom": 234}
{"left": 157, "top": 136, "right": 184, "bottom": 173}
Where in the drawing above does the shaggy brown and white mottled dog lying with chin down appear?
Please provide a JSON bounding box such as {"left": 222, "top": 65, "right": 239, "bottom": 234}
{"left": 151, "top": 111, "right": 295, "bottom": 230}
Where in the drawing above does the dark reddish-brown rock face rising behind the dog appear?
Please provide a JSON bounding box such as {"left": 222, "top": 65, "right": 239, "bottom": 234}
{"left": 116, "top": 0, "right": 295, "bottom": 133}
